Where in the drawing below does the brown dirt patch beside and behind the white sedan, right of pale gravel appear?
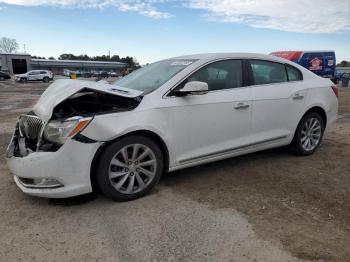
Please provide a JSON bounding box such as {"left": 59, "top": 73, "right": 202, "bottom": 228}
{"left": 163, "top": 89, "right": 350, "bottom": 261}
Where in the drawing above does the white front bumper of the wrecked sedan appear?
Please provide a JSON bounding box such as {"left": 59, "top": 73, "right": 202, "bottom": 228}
{"left": 6, "top": 134, "right": 101, "bottom": 198}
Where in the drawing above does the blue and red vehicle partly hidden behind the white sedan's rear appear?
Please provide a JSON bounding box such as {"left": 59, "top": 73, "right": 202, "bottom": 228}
{"left": 271, "top": 51, "right": 336, "bottom": 81}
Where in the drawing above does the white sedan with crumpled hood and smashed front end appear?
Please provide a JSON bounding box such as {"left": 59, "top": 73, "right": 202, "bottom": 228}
{"left": 6, "top": 53, "right": 338, "bottom": 200}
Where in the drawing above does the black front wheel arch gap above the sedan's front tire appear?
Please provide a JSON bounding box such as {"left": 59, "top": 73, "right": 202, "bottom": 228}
{"left": 90, "top": 129, "right": 170, "bottom": 192}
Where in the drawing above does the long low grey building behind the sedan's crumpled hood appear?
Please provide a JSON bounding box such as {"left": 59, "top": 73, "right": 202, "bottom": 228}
{"left": 0, "top": 53, "right": 127, "bottom": 75}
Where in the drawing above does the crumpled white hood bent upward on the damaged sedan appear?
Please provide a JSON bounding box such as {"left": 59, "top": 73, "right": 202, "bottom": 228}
{"left": 33, "top": 79, "right": 142, "bottom": 122}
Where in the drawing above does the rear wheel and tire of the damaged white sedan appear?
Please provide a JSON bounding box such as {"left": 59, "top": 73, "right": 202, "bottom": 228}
{"left": 290, "top": 112, "right": 324, "bottom": 156}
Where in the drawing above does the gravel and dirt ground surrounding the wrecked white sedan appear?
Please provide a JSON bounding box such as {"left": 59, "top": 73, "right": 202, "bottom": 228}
{"left": 0, "top": 81, "right": 350, "bottom": 261}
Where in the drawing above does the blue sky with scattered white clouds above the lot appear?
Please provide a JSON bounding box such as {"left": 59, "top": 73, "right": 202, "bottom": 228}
{"left": 0, "top": 0, "right": 350, "bottom": 64}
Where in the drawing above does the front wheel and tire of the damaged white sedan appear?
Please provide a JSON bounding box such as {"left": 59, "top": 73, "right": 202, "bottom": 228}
{"left": 96, "top": 136, "right": 164, "bottom": 201}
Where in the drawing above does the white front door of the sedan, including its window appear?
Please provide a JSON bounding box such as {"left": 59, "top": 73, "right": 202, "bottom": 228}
{"left": 166, "top": 60, "right": 252, "bottom": 164}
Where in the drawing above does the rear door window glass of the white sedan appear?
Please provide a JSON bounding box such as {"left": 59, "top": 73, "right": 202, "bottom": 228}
{"left": 249, "top": 60, "right": 288, "bottom": 85}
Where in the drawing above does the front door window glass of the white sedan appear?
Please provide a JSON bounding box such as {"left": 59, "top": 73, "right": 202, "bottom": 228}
{"left": 187, "top": 60, "right": 243, "bottom": 91}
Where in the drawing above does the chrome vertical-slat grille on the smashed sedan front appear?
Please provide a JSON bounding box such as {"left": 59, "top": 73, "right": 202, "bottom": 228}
{"left": 18, "top": 115, "right": 44, "bottom": 143}
